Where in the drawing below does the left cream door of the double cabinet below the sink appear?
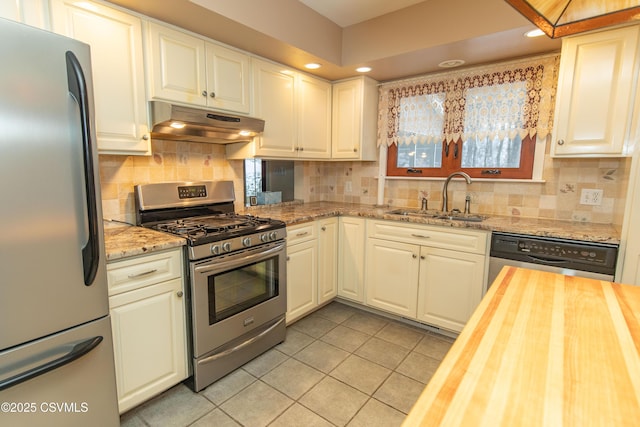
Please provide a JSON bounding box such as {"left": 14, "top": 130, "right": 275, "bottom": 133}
{"left": 365, "top": 239, "right": 420, "bottom": 318}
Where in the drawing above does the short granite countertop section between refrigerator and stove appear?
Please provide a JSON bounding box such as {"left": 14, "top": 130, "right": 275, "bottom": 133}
{"left": 104, "top": 221, "right": 186, "bottom": 262}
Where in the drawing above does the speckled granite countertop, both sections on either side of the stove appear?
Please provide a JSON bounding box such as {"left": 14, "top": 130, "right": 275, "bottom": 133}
{"left": 104, "top": 202, "right": 620, "bottom": 261}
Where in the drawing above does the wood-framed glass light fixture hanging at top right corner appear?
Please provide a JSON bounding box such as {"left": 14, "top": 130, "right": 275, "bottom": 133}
{"left": 505, "top": 0, "right": 640, "bottom": 38}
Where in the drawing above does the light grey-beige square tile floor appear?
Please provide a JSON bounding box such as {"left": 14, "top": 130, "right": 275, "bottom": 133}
{"left": 121, "top": 302, "right": 453, "bottom": 427}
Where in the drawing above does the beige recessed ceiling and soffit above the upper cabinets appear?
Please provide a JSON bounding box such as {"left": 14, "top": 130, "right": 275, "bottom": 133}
{"left": 109, "top": 0, "right": 561, "bottom": 81}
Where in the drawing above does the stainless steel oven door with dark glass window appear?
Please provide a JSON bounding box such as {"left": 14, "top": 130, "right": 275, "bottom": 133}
{"left": 191, "top": 242, "right": 287, "bottom": 358}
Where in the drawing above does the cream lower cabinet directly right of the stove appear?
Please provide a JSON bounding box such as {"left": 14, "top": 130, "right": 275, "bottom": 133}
{"left": 286, "top": 218, "right": 338, "bottom": 323}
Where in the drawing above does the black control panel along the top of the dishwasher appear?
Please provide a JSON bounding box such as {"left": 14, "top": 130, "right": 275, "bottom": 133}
{"left": 491, "top": 232, "right": 618, "bottom": 271}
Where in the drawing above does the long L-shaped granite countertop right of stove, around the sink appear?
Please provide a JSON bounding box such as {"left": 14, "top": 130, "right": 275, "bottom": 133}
{"left": 241, "top": 202, "right": 620, "bottom": 244}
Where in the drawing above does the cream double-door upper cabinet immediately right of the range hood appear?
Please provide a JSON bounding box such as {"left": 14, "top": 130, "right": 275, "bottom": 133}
{"left": 227, "top": 58, "right": 331, "bottom": 160}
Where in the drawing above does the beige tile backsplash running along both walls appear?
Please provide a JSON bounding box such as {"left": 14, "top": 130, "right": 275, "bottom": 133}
{"left": 100, "top": 140, "right": 631, "bottom": 225}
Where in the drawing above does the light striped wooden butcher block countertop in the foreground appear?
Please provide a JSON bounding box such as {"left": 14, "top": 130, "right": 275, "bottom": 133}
{"left": 403, "top": 267, "right": 640, "bottom": 427}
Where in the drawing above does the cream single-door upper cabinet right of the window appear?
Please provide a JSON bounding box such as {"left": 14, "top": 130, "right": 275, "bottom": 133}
{"left": 551, "top": 25, "right": 640, "bottom": 157}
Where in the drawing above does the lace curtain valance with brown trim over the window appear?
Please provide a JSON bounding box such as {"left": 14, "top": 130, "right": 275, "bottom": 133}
{"left": 378, "top": 55, "right": 559, "bottom": 145}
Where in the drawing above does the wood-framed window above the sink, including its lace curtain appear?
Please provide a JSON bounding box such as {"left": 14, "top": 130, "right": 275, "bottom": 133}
{"left": 380, "top": 56, "right": 557, "bottom": 179}
